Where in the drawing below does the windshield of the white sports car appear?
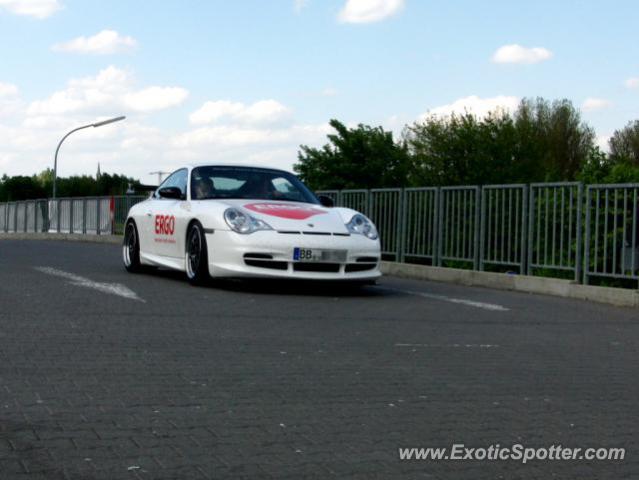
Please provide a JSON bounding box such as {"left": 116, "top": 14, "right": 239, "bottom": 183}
{"left": 191, "top": 166, "right": 319, "bottom": 204}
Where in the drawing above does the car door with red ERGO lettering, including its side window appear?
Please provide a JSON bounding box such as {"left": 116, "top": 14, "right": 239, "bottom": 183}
{"left": 147, "top": 168, "right": 188, "bottom": 258}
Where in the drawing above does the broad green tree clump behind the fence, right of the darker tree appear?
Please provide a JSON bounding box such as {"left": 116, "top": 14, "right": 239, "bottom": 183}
{"left": 405, "top": 99, "right": 597, "bottom": 185}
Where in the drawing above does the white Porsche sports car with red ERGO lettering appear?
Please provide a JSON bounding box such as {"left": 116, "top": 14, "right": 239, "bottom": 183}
{"left": 122, "top": 165, "right": 381, "bottom": 284}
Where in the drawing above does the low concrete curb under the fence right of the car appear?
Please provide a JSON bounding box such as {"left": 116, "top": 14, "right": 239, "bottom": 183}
{"left": 381, "top": 262, "right": 639, "bottom": 308}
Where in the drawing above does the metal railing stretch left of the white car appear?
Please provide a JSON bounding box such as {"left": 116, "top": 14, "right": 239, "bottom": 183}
{"left": 0, "top": 196, "right": 147, "bottom": 235}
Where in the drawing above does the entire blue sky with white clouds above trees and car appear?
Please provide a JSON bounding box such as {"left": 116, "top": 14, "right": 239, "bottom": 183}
{"left": 0, "top": 0, "right": 639, "bottom": 183}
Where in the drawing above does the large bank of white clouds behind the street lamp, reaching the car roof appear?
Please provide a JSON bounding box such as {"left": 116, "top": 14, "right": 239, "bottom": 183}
{"left": 0, "top": 74, "right": 331, "bottom": 184}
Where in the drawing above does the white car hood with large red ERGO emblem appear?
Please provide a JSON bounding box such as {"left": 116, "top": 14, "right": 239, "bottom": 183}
{"left": 221, "top": 200, "right": 348, "bottom": 233}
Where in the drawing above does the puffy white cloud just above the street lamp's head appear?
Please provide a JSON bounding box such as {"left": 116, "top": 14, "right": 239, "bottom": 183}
{"left": 27, "top": 66, "right": 188, "bottom": 116}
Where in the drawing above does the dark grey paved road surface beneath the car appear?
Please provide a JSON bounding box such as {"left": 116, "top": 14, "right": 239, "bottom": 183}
{"left": 0, "top": 241, "right": 639, "bottom": 480}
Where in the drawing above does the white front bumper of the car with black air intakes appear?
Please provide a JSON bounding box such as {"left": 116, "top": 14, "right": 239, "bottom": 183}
{"left": 206, "top": 230, "right": 381, "bottom": 281}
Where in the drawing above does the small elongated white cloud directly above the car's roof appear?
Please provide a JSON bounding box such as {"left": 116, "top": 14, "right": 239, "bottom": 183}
{"left": 189, "top": 100, "right": 291, "bottom": 125}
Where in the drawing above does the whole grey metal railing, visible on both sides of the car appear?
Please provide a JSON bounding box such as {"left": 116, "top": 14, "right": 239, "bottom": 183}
{"left": 0, "top": 182, "right": 639, "bottom": 285}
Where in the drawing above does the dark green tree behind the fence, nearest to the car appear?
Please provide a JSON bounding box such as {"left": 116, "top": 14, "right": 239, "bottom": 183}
{"left": 294, "top": 120, "right": 411, "bottom": 190}
